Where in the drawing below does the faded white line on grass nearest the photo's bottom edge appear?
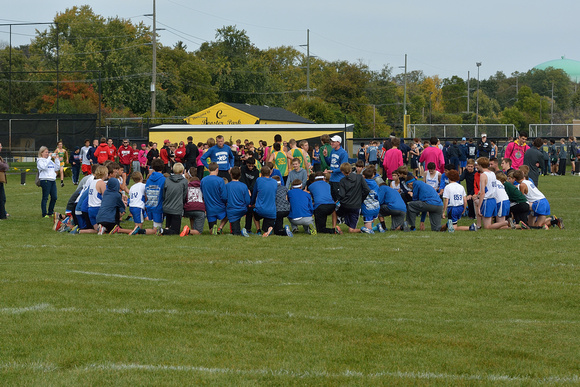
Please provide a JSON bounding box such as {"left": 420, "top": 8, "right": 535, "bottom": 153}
{"left": 0, "top": 362, "right": 580, "bottom": 383}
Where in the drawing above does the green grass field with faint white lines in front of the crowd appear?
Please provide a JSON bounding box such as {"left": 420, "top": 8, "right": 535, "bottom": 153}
{"left": 0, "top": 171, "right": 580, "bottom": 385}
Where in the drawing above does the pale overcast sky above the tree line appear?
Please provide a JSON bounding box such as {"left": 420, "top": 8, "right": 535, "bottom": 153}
{"left": 0, "top": 0, "right": 580, "bottom": 79}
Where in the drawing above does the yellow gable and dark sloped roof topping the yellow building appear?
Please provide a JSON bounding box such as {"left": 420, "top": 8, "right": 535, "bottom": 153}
{"left": 185, "top": 102, "right": 314, "bottom": 125}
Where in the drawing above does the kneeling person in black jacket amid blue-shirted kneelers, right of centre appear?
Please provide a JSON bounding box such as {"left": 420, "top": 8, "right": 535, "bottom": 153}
{"left": 337, "top": 163, "right": 371, "bottom": 233}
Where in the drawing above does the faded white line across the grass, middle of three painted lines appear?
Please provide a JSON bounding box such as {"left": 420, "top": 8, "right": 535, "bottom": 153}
{"left": 0, "top": 303, "right": 580, "bottom": 325}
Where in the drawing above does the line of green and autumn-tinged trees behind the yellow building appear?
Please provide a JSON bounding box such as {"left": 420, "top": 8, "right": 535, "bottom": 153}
{"left": 0, "top": 5, "right": 580, "bottom": 137}
